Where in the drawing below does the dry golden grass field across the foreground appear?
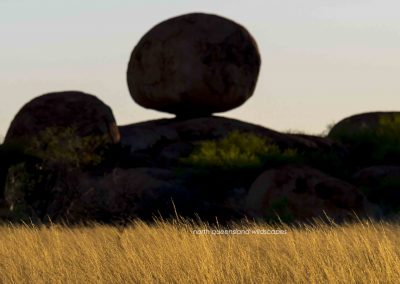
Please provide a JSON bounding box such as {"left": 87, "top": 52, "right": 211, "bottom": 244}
{"left": 0, "top": 221, "right": 400, "bottom": 283}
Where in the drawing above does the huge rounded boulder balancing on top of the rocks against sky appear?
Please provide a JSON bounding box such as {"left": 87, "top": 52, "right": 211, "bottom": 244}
{"left": 127, "top": 13, "right": 261, "bottom": 117}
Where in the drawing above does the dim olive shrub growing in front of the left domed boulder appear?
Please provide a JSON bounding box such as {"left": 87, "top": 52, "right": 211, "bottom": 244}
{"left": 4, "top": 127, "right": 107, "bottom": 220}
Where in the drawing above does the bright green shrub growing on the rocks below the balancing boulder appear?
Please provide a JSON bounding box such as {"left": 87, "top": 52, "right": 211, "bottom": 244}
{"left": 182, "top": 131, "right": 297, "bottom": 170}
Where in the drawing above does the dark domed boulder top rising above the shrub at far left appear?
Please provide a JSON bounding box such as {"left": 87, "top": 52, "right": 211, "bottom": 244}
{"left": 4, "top": 91, "right": 120, "bottom": 143}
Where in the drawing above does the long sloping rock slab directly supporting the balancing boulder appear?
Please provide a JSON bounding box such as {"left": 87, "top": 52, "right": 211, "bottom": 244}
{"left": 119, "top": 116, "right": 344, "bottom": 166}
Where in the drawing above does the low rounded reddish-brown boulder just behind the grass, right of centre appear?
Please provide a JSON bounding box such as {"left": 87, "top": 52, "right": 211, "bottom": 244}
{"left": 246, "top": 166, "right": 372, "bottom": 223}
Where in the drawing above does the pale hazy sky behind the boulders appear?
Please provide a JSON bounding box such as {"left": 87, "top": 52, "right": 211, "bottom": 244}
{"left": 0, "top": 0, "right": 400, "bottom": 140}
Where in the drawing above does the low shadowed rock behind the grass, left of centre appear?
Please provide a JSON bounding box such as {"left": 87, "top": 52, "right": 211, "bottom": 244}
{"left": 64, "top": 168, "right": 193, "bottom": 221}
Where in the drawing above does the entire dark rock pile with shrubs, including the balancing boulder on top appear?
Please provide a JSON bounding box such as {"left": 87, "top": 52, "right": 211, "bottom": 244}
{"left": 0, "top": 13, "right": 394, "bottom": 222}
